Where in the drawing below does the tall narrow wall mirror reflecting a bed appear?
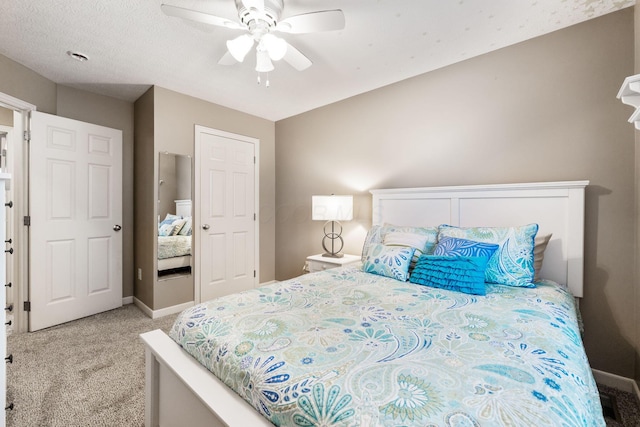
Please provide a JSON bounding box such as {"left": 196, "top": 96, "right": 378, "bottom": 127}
{"left": 157, "top": 153, "right": 193, "bottom": 279}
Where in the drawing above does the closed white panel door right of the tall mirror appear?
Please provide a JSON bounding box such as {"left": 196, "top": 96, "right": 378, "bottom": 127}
{"left": 194, "top": 126, "right": 258, "bottom": 301}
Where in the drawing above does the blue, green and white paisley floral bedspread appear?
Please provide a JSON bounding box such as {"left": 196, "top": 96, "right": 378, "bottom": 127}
{"left": 170, "top": 267, "right": 605, "bottom": 427}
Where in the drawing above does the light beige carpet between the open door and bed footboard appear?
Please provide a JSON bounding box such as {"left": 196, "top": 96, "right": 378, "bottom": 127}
{"left": 7, "top": 304, "right": 176, "bottom": 427}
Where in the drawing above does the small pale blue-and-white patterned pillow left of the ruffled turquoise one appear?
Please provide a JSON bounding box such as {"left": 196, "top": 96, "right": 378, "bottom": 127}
{"left": 362, "top": 243, "right": 415, "bottom": 282}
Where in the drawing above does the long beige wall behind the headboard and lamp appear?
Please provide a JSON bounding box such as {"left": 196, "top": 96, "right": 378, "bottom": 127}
{"left": 276, "top": 9, "right": 637, "bottom": 377}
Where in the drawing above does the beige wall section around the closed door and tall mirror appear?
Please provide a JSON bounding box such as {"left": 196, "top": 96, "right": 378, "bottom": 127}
{"left": 135, "top": 86, "right": 276, "bottom": 310}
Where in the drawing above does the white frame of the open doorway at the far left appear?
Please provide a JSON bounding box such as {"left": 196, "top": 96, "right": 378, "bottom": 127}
{"left": 0, "top": 92, "right": 37, "bottom": 332}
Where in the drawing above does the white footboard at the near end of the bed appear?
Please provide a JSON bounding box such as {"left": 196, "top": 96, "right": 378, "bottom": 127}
{"left": 140, "top": 330, "right": 272, "bottom": 427}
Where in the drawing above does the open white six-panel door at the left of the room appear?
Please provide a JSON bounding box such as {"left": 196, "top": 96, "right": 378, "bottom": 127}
{"left": 29, "top": 112, "right": 122, "bottom": 331}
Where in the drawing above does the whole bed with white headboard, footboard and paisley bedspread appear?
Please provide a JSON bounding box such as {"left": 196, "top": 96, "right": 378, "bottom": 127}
{"left": 142, "top": 181, "right": 604, "bottom": 426}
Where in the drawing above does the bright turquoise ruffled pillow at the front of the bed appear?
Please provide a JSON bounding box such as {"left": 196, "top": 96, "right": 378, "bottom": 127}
{"left": 409, "top": 255, "right": 488, "bottom": 295}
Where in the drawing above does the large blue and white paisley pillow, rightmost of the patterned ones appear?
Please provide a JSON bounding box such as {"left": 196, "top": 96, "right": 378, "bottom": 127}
{"left": 438, "top": 224, "right": 538, "bottom": 288}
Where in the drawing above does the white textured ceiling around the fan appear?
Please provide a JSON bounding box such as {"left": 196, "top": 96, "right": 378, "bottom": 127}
{"left": 0, "top": 0, "right": 635, "bottom": 121}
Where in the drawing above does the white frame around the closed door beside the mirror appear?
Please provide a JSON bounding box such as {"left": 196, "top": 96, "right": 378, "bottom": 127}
{"left": 191, "top": 125, "right": 260, "bottom": 304}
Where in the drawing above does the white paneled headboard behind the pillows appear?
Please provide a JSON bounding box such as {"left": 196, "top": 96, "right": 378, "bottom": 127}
{"left": 371, "top": 181, "right": 589, "bottom": 297}
